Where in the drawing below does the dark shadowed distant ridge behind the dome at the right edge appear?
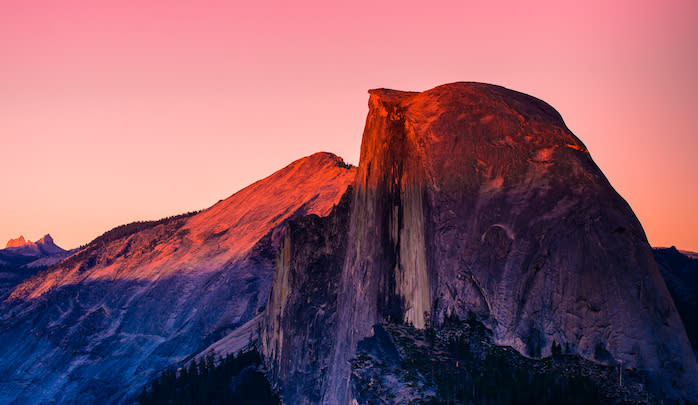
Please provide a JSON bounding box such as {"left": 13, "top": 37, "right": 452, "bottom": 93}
{"left": 654, "top": 247, "right": 698, "bottom": 357}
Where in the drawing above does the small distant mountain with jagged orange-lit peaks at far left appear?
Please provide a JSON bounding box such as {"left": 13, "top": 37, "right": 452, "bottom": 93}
{"left": 0, "top": 234, "right": 72, "bottom": 300}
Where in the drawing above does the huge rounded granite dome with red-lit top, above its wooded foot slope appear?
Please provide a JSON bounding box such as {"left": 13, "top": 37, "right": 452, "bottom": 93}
{"left": 265, "top": 83, "right": 698, "bottom": 403}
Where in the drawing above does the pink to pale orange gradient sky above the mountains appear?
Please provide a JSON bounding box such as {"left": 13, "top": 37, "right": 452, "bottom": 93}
{"left": 0, "top": 0, "right": 698, "bottom": 251}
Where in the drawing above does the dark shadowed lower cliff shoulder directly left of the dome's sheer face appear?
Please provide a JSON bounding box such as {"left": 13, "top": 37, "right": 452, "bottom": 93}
{"left": 262, "top": 188, "right": 352, "bottom": 404}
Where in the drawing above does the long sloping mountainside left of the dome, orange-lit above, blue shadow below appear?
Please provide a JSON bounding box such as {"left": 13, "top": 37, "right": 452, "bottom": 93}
{"left": 0, "top": 153, "right": 356, "bottom": 403}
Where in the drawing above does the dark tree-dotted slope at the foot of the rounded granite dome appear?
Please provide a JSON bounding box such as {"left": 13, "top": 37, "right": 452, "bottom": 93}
{"left": 351, "top": 319, "right": 659, "bottom": 405}
